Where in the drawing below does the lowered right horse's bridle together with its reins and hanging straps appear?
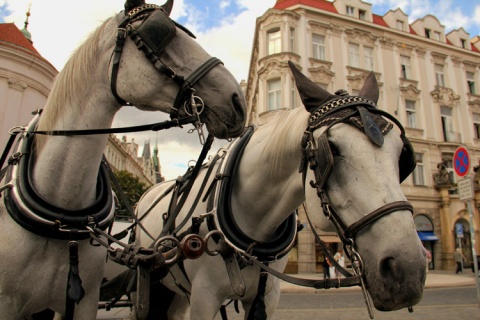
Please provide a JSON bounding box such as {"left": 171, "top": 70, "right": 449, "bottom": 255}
{"left": 221, "top": 94, "right": 416, "bottom": 319}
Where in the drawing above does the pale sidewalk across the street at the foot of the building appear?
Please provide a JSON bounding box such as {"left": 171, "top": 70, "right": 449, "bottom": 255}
{"left": 280, "top": 269, "right": 475, "bottom": 293}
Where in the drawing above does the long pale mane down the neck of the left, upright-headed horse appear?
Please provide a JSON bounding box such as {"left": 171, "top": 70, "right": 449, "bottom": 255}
{"left": 38, "top": 18, "right": 113, "bottom": 130}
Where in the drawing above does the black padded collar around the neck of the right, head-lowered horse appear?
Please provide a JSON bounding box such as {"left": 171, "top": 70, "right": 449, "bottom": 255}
{"left": 207, "top": 127, "right": 297, "bottom": 262}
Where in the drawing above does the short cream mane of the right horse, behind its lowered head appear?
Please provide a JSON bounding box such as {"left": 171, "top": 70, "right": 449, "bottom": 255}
{"left": 257, "top": 107, "right": 309, "bottom": 176}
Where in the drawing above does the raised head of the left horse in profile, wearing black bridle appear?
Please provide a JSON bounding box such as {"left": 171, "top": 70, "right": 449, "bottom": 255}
{"left": 111, "top": 0, "right": 246, "bottom": 138}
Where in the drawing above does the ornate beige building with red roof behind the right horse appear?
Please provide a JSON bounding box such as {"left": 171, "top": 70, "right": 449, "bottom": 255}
{"left": 246, "top": 0, "right": 480, "bottom": 272}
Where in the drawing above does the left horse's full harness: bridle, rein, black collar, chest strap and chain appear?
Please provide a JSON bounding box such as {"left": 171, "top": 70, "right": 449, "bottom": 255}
{"left": 0, "top": 4, "right": 227, "bottom": 319}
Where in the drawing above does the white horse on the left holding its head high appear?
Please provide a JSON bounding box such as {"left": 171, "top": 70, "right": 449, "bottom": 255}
{"left": 0, "top": 0, "right": 246, "bottom": 320}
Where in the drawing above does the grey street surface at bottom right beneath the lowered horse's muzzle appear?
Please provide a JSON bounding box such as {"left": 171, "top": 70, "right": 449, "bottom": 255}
{"left": 216, "top": 286, "right": 480, "bottom": 320}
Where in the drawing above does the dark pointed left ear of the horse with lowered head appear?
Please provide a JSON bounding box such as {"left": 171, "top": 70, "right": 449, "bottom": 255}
{"left": 288, "top": 61, "right": 335, "bottom": 113}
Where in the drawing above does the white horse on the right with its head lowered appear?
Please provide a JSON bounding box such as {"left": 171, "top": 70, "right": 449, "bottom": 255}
{"left": 133, "top": 61, "right": 426, "bottom": 320}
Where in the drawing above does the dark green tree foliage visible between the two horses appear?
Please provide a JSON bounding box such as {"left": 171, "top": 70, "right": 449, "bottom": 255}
{"left": 112, "top": 170, "right": 148, "bottom": 218}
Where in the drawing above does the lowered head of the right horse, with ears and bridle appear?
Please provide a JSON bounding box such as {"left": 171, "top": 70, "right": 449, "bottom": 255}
{"left": 290, "top": 63, "right": 426, "bottom": 311}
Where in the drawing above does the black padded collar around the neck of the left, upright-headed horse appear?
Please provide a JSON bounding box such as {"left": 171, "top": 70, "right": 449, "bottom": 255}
{"left": 4, "top": 115, "right": 115, "bottom": 240}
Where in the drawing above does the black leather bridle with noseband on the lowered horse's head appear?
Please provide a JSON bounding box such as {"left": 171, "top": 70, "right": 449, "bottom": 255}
{"left": 300, "top": 96, "right": 415, "bottom": 249}
